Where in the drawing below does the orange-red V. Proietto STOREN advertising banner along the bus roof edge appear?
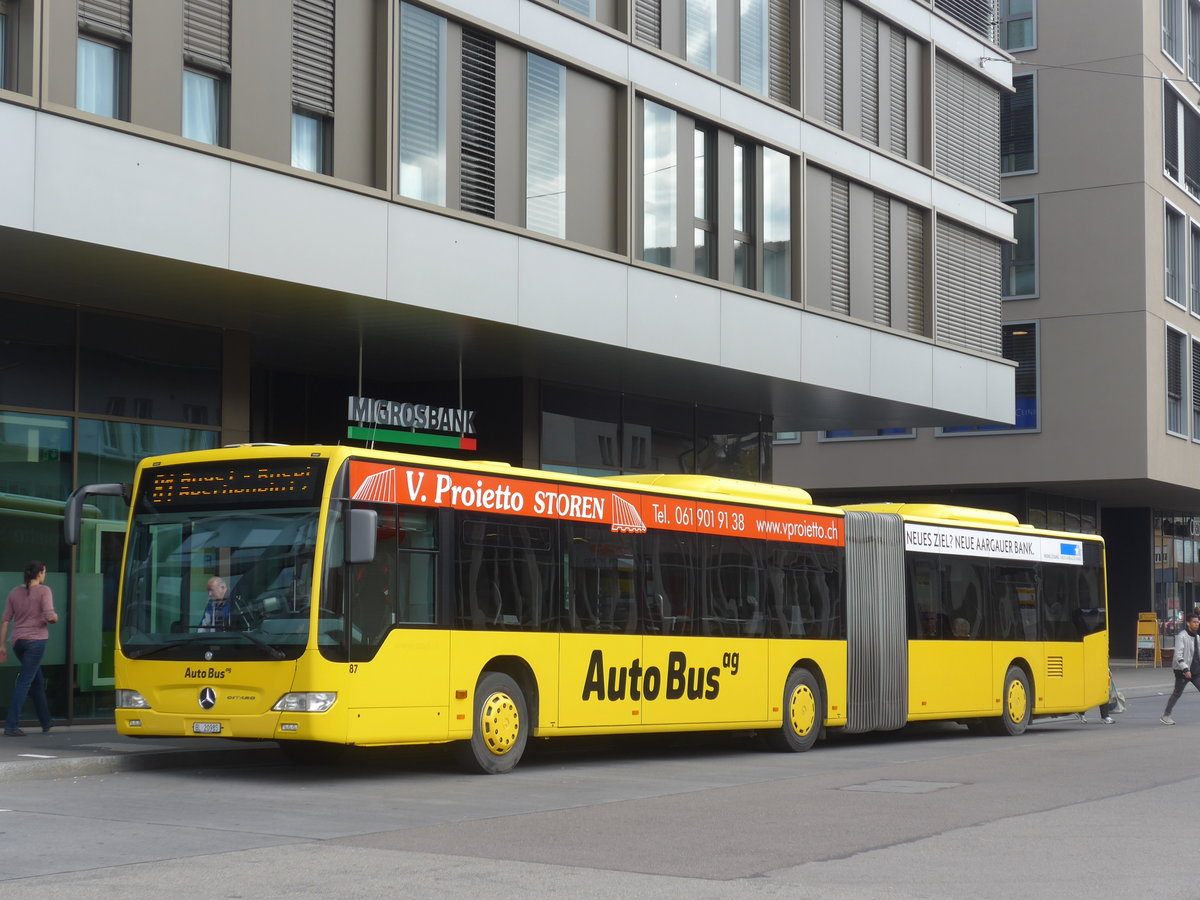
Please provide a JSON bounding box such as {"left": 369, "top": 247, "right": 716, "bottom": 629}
{"left": 350, "top": 460, "right": 845, "bottom": 546}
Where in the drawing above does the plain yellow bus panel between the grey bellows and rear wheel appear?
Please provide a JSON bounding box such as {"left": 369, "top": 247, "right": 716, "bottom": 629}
{"left": 908, "top": 640, "right": 1003, "bottom": 720}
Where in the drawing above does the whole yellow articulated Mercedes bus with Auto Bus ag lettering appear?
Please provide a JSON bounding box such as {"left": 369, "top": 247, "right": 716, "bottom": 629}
{"left": 65, "top": 446, "right": 1108, "bottom": 773}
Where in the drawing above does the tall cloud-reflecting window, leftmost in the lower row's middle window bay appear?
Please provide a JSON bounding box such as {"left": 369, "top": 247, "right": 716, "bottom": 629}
{"left": 642, "top": 100, "right": 679, "bottom": 266}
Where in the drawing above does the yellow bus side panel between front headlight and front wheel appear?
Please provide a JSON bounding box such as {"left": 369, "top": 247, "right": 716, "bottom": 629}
{"left": 347, "top": 628, "right": 450, "bottom": 744}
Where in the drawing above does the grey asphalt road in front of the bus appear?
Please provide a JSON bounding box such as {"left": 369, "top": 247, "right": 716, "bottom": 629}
{"left": 0, "top": 681, "right": 1200, "bottom": 900}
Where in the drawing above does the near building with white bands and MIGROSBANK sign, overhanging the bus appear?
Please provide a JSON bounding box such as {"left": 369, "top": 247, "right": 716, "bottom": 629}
{"left": 0, "top": 0, "right": 1014, "bottom": 719}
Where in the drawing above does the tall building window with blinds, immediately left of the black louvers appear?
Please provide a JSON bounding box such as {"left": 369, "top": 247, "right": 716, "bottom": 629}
{"left": 397, "top": 2, "right": 446, "bottom": 206}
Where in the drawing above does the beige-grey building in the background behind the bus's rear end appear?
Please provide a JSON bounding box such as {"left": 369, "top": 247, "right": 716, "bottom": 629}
{"left": 775, "top": 0, "right": 1200, "bottom": 658}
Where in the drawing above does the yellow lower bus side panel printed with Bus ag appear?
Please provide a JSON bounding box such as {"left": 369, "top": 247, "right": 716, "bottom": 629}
{"left": 642, "top": 636, "right": 769, "bottom": 726}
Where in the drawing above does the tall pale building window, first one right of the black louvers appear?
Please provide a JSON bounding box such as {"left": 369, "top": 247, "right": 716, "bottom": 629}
{"left": 526, "top": 53, "right": 566, "bottom": 238}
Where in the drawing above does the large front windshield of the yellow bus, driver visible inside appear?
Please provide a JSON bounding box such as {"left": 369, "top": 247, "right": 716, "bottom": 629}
{"left": 120, "top": 509, "right": 318, "bottom": 660}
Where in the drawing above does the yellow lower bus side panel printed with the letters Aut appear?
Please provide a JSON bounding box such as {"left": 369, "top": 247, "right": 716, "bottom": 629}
{"left": 558, "top": 634, "right": 643, "bottom": 728}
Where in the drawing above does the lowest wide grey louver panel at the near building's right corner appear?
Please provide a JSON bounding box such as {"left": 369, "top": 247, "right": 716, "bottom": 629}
{"left": 934, "top": 218, "right": 1001, "bottom": 356}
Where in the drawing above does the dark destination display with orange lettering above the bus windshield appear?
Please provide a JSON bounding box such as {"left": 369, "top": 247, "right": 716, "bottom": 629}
{"left": 142, "top": 460, "right": 325, "bottom": 512}
